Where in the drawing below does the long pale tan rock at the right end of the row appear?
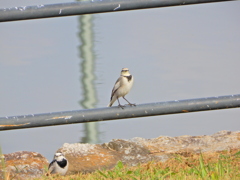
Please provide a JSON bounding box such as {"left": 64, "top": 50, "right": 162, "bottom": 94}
{"left": 130, "top": 131, "right": 240, "bottom": 154}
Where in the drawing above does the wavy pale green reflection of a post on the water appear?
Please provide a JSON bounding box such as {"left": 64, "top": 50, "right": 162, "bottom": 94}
{"left": 79, "top": 15, "right": 99, "bottom": 143}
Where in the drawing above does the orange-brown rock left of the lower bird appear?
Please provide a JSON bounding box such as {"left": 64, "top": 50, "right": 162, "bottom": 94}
{"left": 0, "top": 151, "right": 48, "bottom": 180}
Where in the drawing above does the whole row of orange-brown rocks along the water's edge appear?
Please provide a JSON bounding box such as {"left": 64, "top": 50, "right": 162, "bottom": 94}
{"left": 0, "top": 131, "right": 240, "bottom": 179}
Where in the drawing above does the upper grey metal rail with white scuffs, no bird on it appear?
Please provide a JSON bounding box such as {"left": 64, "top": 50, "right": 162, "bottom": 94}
{"left": 0, "top": 0, "right": 234, "bottom": 22}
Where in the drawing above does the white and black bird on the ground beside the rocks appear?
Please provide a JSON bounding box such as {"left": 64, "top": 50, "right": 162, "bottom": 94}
{"left": 48, "top": 153, "right": 69, "bottom": 176}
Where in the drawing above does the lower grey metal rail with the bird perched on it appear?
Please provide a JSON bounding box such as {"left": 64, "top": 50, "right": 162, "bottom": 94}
{"left": 0, "top": 94, "right": 240, "bottom": 130}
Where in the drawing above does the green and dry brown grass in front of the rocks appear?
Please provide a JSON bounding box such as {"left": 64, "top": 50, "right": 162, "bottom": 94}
{"left": 40, "top": 150, "right": 240, "bottom": 180}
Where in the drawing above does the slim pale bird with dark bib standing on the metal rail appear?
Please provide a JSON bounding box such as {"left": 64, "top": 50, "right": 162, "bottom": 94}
{"left": 108, "top": 68, "right": 136, "bottom": 109}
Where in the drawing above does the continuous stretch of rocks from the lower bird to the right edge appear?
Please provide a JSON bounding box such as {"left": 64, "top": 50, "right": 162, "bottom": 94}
{"left": 57, "top": 131, "right": 240, "bottom": 174}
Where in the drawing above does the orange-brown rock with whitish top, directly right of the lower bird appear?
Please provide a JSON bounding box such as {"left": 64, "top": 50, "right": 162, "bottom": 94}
{"left": 57, "top": 143, "right": 121, "bottom": 174}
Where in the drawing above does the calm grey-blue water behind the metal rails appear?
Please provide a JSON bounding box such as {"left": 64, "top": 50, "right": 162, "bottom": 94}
{"left": 0, "top": 0, "right": 240, "bottom": 160}
